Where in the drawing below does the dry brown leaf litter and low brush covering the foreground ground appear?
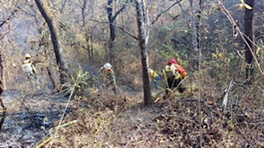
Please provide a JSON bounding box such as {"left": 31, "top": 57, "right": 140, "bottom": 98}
{"left": 40, "top": 81, "right": 264, "bottom": 148}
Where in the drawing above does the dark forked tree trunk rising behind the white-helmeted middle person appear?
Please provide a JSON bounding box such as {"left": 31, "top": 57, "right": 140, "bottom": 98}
{"left": 107, "top": 0, "right": 128, "bottom": 62}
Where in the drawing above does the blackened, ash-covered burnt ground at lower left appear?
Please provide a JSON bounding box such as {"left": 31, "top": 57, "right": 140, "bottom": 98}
{"left": 0, "top": 90, "right": 73, "bottom": 147}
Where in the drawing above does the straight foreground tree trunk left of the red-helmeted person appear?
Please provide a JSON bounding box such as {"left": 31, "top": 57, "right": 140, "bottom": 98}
{"left": 135, "top": 0, "right": 153, "bottom": 106}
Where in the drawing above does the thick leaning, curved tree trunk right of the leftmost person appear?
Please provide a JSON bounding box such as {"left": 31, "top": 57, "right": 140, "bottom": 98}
{"left": 35, "top": 0, "right": 66, "bottom": 84}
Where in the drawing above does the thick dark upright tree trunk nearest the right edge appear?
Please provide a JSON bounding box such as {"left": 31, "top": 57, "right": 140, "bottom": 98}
{"left": 244, "top": 0, "right": 254, "bottom": 79}
